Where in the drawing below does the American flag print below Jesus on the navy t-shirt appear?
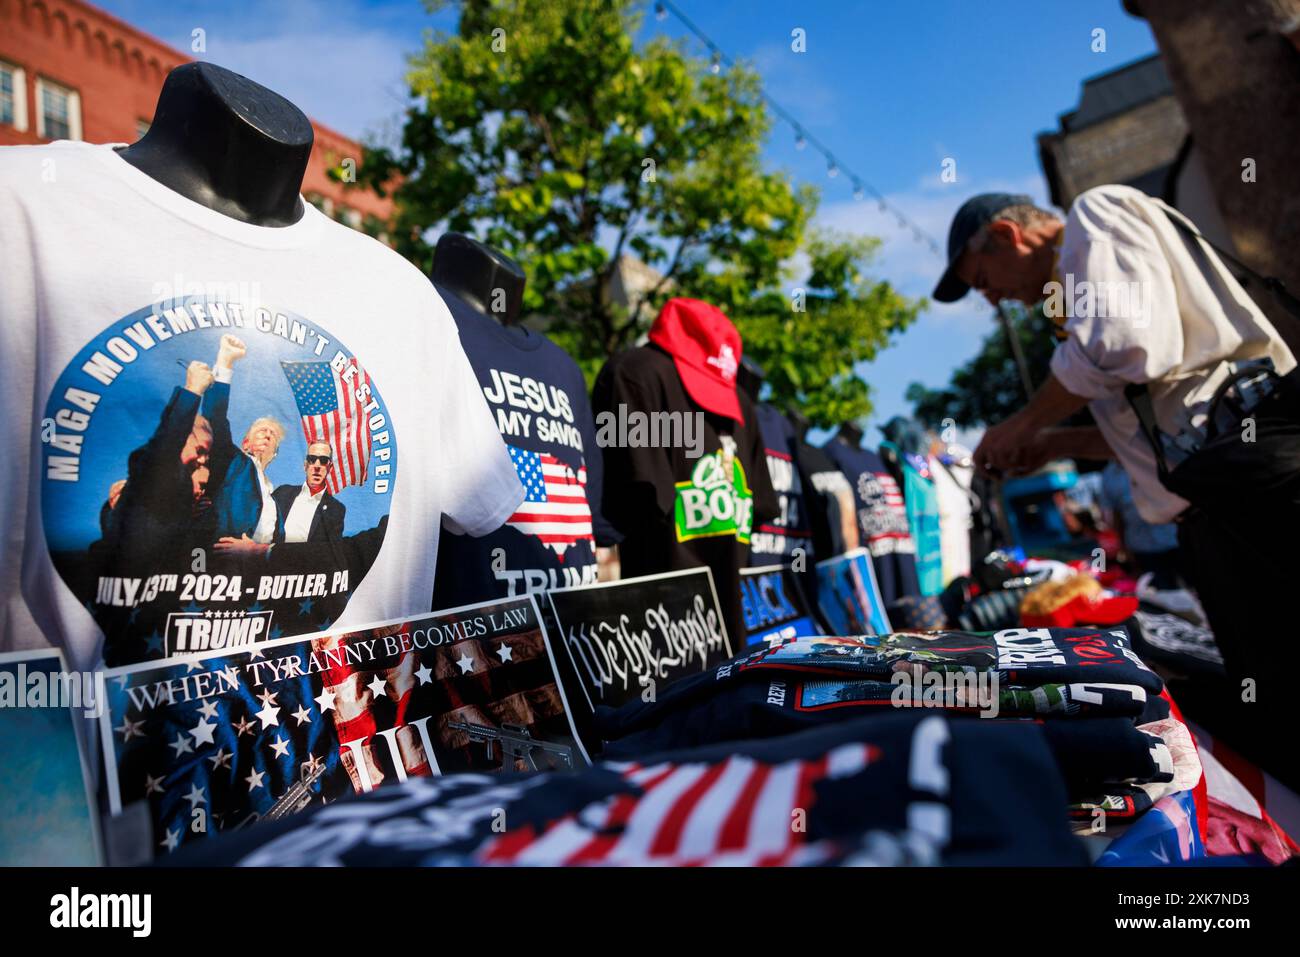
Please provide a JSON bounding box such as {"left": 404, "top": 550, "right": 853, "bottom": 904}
{"left": 506, "top": 445, "right": 595, "bottom": 560}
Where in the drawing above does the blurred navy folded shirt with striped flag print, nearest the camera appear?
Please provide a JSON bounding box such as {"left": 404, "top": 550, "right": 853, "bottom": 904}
{"left": 172, "top": 713, "right": 1087, "bottom": 866}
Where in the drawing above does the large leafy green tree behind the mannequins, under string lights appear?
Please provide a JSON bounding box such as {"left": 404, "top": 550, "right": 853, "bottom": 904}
{"left": 359, "top": 0, "right": 920, "bottom": 425}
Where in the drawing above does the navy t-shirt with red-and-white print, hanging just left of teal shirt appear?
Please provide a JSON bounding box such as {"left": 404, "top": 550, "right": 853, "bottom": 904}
{"left": 822, "top": 438, "right": 920, "bottom": 606}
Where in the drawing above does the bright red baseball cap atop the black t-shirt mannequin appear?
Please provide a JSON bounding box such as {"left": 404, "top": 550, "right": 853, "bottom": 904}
{"left": 650, "top": 299, "right": 745, "bottom": 425}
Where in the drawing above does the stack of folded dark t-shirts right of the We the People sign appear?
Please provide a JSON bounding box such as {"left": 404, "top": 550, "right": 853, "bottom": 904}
{"left": 595, "top": 628, "right": 1174, "bottom": 832}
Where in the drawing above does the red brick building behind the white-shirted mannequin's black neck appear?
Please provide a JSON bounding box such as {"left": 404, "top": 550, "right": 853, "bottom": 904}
{"left": 0, "top": 0, "right": 393, "bottom": 238}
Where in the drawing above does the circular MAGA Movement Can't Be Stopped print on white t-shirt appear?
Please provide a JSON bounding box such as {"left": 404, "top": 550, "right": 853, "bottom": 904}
{"left": 40, "top": 298, "right": 398, "bottom": 666}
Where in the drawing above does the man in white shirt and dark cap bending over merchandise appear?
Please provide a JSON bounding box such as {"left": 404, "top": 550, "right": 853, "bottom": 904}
{"left": 935, "top": 186, "right": 1300, "bottom": 785}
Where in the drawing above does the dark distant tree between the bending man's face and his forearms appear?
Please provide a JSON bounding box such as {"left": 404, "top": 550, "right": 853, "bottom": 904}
{"left": 906, "top": 303, "right": 1056, "bottom": 429}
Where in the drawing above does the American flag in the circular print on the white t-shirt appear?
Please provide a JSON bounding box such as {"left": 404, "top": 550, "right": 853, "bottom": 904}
{"left": 280, "top": 359, "right": 371, "bottom": 495}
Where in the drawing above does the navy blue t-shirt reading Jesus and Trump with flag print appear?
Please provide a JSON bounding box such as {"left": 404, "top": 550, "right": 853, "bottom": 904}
{"left": 433, "top": 287, "right": 619, "bottom": 609}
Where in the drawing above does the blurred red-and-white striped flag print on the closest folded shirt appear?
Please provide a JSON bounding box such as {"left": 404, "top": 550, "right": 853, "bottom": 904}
{"left": 475, "top": 742, "right": 880, "bottom": 867}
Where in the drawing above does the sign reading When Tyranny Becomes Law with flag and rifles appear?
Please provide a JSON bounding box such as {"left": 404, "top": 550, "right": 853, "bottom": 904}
{"left": 100, "top": 597, "right": 586, "bottom": 854}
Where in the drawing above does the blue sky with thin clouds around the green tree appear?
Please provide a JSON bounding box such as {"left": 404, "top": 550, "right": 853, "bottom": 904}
{"left": 99, "top": 0, "right": 1156, "bottom": 442}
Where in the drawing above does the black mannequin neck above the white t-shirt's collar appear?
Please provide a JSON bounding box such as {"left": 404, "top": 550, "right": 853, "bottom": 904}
{"left": 118, "top": 62, "right": 313, "bottom": 226}
